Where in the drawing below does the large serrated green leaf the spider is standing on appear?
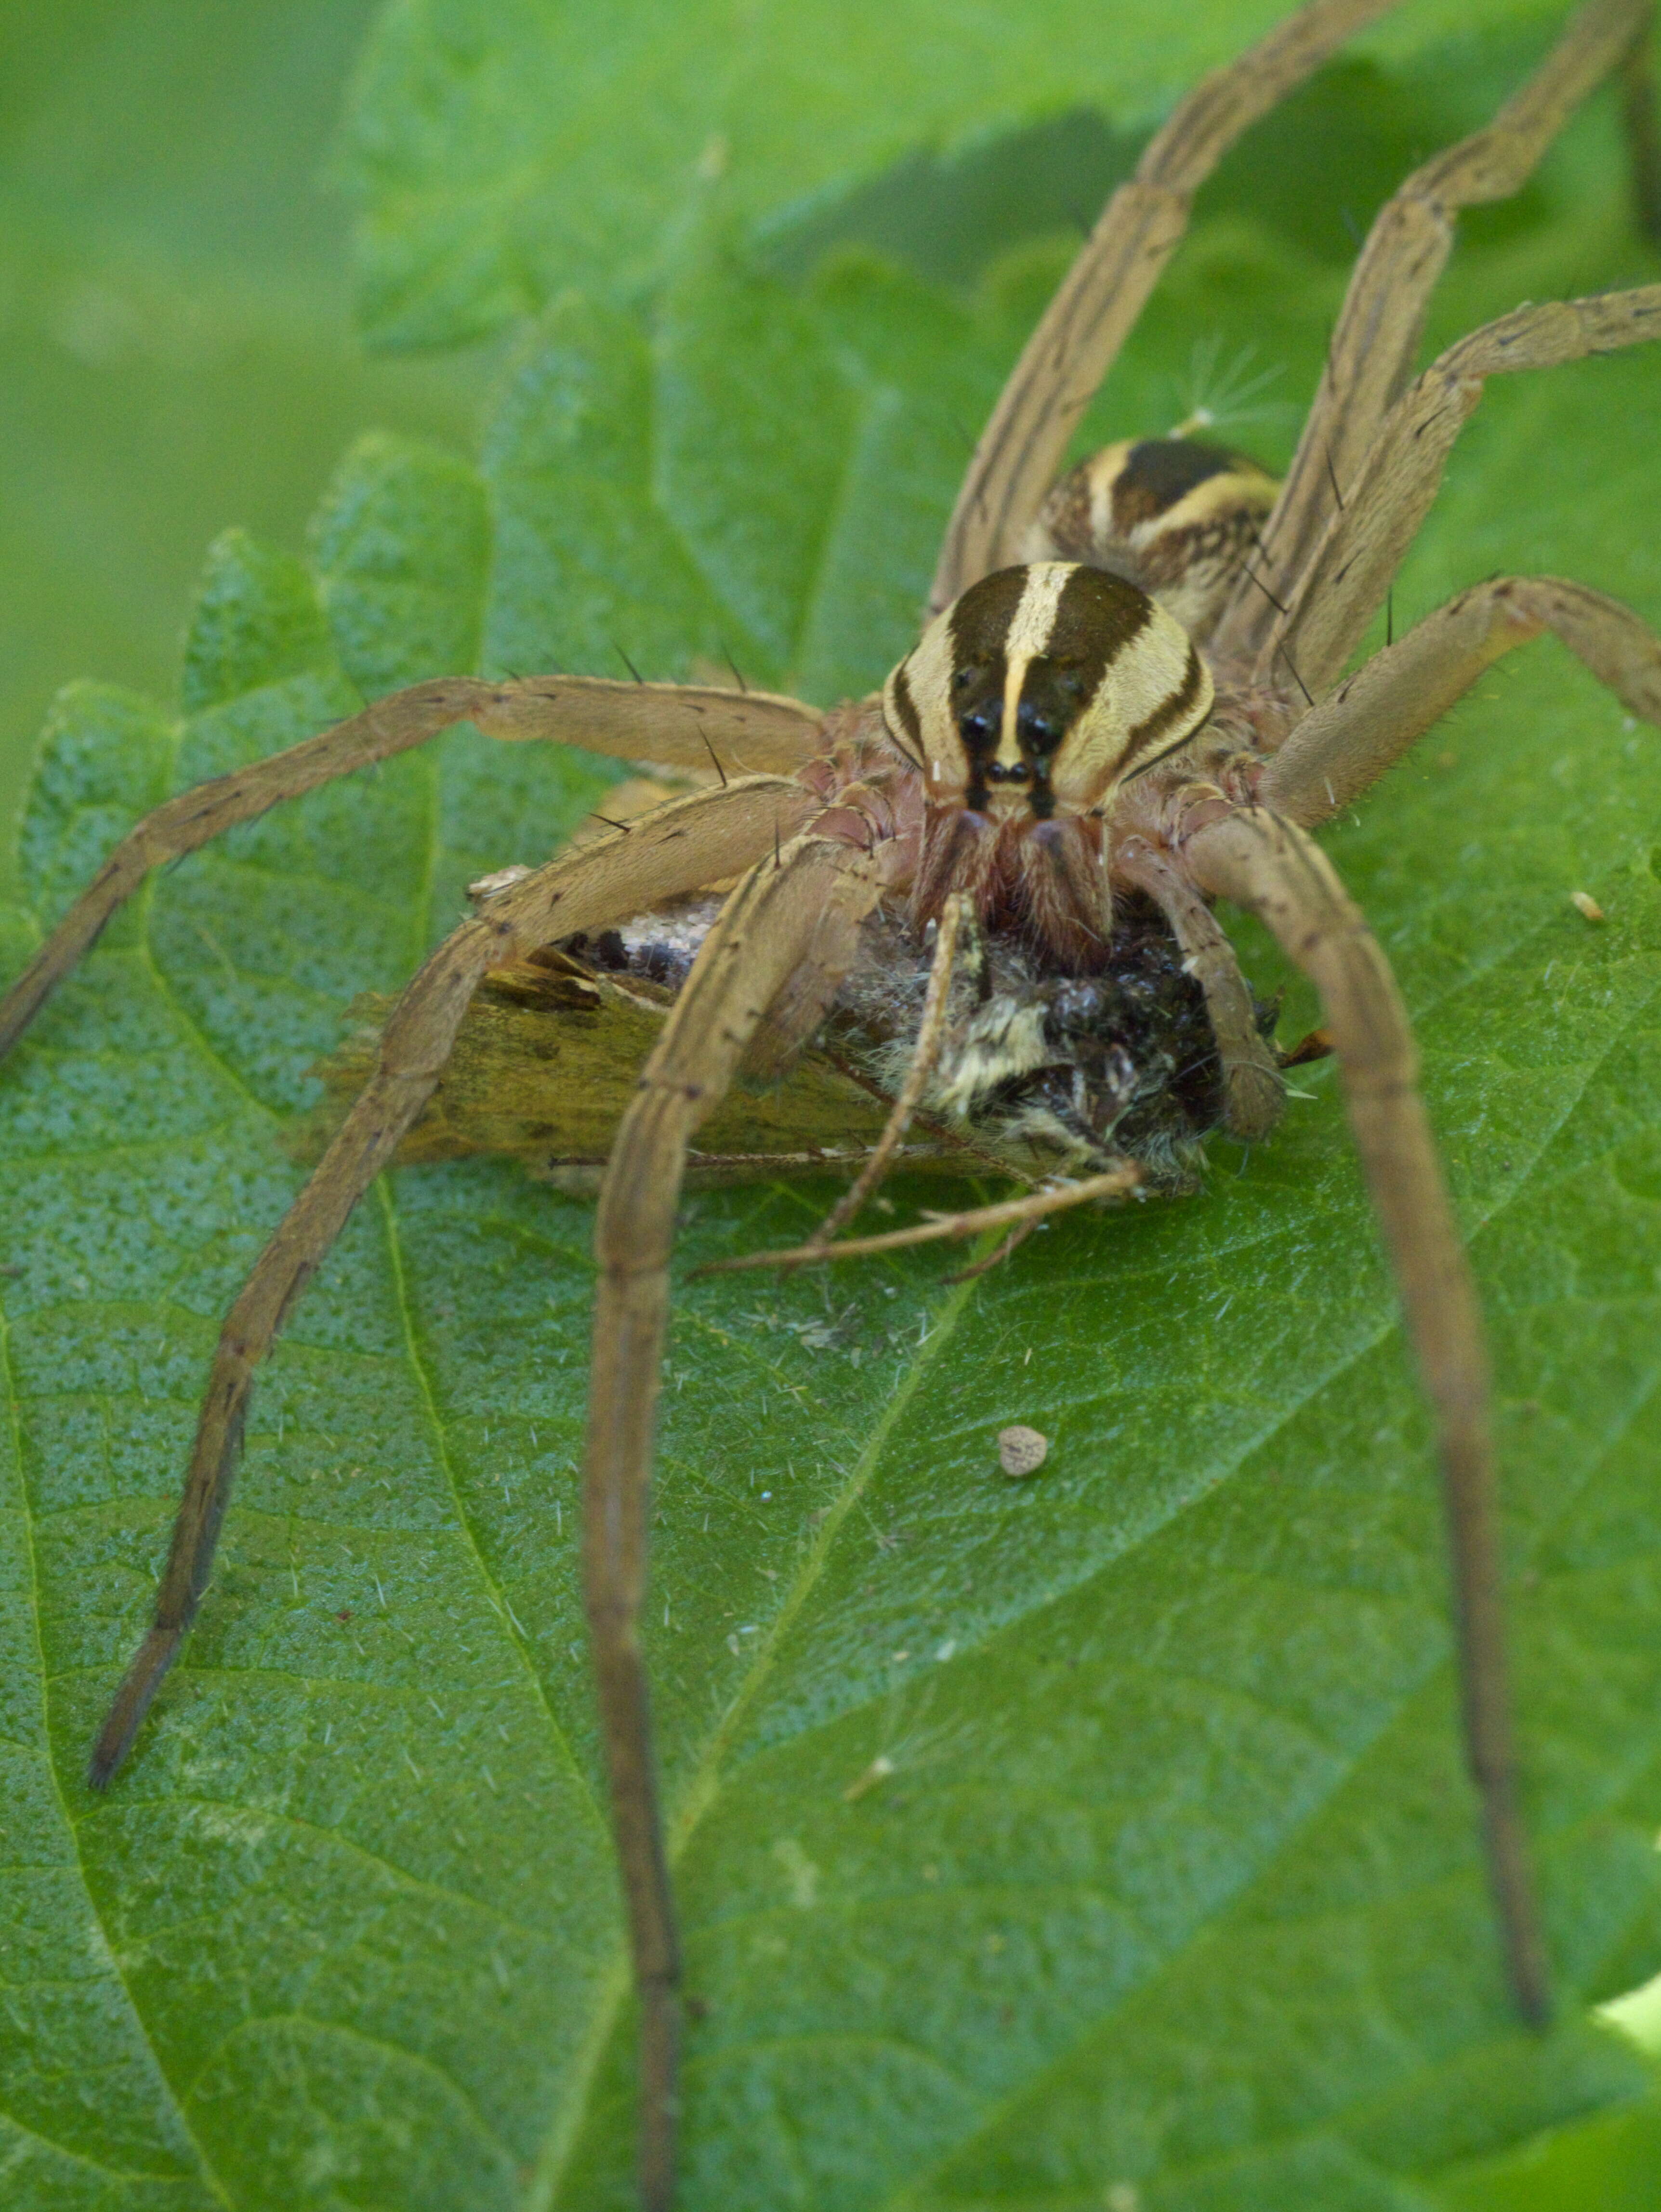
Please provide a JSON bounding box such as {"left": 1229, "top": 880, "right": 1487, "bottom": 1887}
{"left": 0, "top": 18, "right": 1661, "bottom": 2212}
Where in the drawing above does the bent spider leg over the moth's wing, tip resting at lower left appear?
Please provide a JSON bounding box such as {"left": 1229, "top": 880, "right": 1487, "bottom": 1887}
{"left": 89, "top": 777, "right": 818, "bottom": 1790}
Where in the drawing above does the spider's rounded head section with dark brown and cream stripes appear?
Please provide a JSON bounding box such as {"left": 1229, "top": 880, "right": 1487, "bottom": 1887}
{"left": 883, "top": 562, "right": 1212, "bottom": 825}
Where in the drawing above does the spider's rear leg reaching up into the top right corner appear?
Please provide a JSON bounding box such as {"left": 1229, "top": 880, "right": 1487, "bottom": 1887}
{"left": 1212, "top": 0, "right": 1650, "bottom": 664}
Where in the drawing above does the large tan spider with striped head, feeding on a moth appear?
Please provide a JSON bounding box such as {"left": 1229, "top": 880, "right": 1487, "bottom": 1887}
{"left": 0, "top": 0, "right": 1661, "bottom": 2208}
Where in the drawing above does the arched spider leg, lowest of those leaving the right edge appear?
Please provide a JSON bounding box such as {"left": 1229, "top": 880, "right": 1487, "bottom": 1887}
{"left": 1256, "top": 575, "right": 1661, "bottom": 830}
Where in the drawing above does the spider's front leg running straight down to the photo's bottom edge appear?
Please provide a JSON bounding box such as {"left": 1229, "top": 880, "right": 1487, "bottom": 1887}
{"left": 584, "top": 834, "right": 913, "bottom": 2212}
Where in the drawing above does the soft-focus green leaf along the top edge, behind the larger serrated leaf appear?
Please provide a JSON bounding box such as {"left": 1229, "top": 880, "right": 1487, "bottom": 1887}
{"left": 341, "top": 0, "right": 1583, "bottom": 345}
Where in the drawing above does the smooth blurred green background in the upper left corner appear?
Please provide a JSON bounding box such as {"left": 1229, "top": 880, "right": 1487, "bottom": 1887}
{"left": 0, "top": 0, "right": 487, "bottom": 892}
